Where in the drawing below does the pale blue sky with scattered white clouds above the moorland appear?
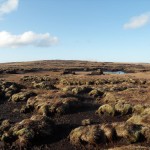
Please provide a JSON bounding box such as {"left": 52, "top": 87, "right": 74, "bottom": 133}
{"left": 0, "top": 0, "right": 150, "bottom": 63}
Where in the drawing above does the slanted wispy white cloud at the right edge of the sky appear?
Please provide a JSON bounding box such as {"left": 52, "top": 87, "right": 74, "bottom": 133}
{"left": 123, "top": 13, "right": 150, "bottom": 29}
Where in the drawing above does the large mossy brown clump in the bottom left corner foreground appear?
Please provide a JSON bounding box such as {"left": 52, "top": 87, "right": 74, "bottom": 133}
{"left": 1, "top": 115, "right": 54, "bottom": 146}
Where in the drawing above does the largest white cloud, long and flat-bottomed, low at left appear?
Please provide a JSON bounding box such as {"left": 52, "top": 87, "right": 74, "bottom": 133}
{"left": 0, "top": 31, "right": 58, "bottom": 48}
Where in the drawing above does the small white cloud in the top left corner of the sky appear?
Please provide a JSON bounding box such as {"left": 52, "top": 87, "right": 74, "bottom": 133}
{"left": 0, "top": 0, "right": 19, "bottom": 17}
